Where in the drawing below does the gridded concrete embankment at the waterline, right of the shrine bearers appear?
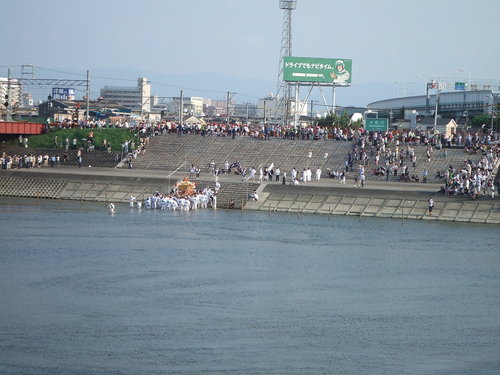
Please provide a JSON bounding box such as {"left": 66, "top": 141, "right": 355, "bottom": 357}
{"left": 245, "top": 180, "right": 500, "bottom": 224}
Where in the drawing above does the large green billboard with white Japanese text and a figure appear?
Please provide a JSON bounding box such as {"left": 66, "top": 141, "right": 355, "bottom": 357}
{"left": 283, "top": 57, "right": 352, "bottom": 86}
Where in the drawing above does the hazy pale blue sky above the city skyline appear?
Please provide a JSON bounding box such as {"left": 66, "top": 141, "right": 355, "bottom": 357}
{"left": 0, "top": 0, "right": 500, "bottom": 106}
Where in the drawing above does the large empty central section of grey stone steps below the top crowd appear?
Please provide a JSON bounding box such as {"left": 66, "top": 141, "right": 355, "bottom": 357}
{"left": 134, "top": 134, "right": 351, "bottom": 173}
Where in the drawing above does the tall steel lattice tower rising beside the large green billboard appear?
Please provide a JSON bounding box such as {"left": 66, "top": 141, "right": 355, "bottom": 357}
{"left": 276, "top": 0, "right": 297, "bottom": 123}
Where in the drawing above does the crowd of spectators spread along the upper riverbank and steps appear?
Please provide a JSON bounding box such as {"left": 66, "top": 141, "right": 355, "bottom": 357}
{"left": 0, "top": 120, "right": 500, "bottom": 203}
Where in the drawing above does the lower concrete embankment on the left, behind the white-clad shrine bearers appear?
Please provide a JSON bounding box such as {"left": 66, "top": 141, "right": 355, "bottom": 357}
{"left": 0, "top": 167, "right": 258, "bottom": 209}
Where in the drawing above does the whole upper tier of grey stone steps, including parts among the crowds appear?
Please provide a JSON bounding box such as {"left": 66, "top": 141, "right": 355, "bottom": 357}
{"left": 0, "top": 133, "right": 490, "bottom": 189}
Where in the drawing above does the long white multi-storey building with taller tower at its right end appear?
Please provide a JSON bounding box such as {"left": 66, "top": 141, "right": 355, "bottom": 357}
{"left": 101, "top": 77, "right": 151, "bottom": 113}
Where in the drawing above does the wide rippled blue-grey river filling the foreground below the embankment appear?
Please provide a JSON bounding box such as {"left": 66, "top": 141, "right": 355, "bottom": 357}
{"left": 0, "top": 198, "right": 500, "bottom": 375}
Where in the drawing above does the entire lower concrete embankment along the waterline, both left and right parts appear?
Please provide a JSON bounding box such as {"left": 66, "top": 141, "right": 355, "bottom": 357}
{"left": 0, "top": 168, "right": 500, "bottom": 224}
